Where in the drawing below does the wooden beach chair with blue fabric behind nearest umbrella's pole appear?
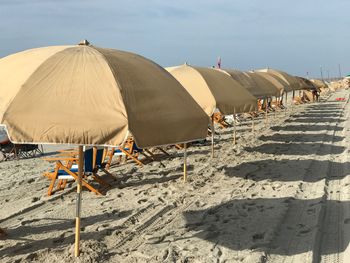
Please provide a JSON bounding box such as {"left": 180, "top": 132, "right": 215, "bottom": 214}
{"left": 44, "top": 148, "right": 112, "bottom": 196}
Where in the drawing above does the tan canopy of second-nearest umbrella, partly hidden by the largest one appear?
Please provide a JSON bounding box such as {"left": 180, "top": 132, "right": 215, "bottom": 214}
{"left": 166, "top": 64, "right": 257, "bottom": 116}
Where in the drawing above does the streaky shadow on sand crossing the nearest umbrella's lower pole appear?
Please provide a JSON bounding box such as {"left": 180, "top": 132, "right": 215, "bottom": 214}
{"left": 0, "top": 210, "right": 132, "bottom": 261}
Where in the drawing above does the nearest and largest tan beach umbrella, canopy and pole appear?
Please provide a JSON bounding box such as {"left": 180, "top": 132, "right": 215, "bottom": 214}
{"left": 0, "top": 41, "right": 208, "bottom": 256}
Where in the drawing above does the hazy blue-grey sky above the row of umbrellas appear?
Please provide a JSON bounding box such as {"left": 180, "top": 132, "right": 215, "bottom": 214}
{"left": 0, "top": 0, "right": 350, "bottom": 78}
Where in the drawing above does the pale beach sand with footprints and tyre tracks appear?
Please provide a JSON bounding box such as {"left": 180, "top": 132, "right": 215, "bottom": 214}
{"left": 0, "top": 90, "right": 350, "bottom": 262}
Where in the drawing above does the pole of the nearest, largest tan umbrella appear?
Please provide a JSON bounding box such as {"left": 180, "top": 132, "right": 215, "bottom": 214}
{"left": 74, "top": 146, "right": 84, "bottom": 257}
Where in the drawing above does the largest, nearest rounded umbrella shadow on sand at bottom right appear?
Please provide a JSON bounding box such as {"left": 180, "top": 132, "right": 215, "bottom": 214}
{"left": 184, "top": 198, "right": 350, "bottom": 255}
